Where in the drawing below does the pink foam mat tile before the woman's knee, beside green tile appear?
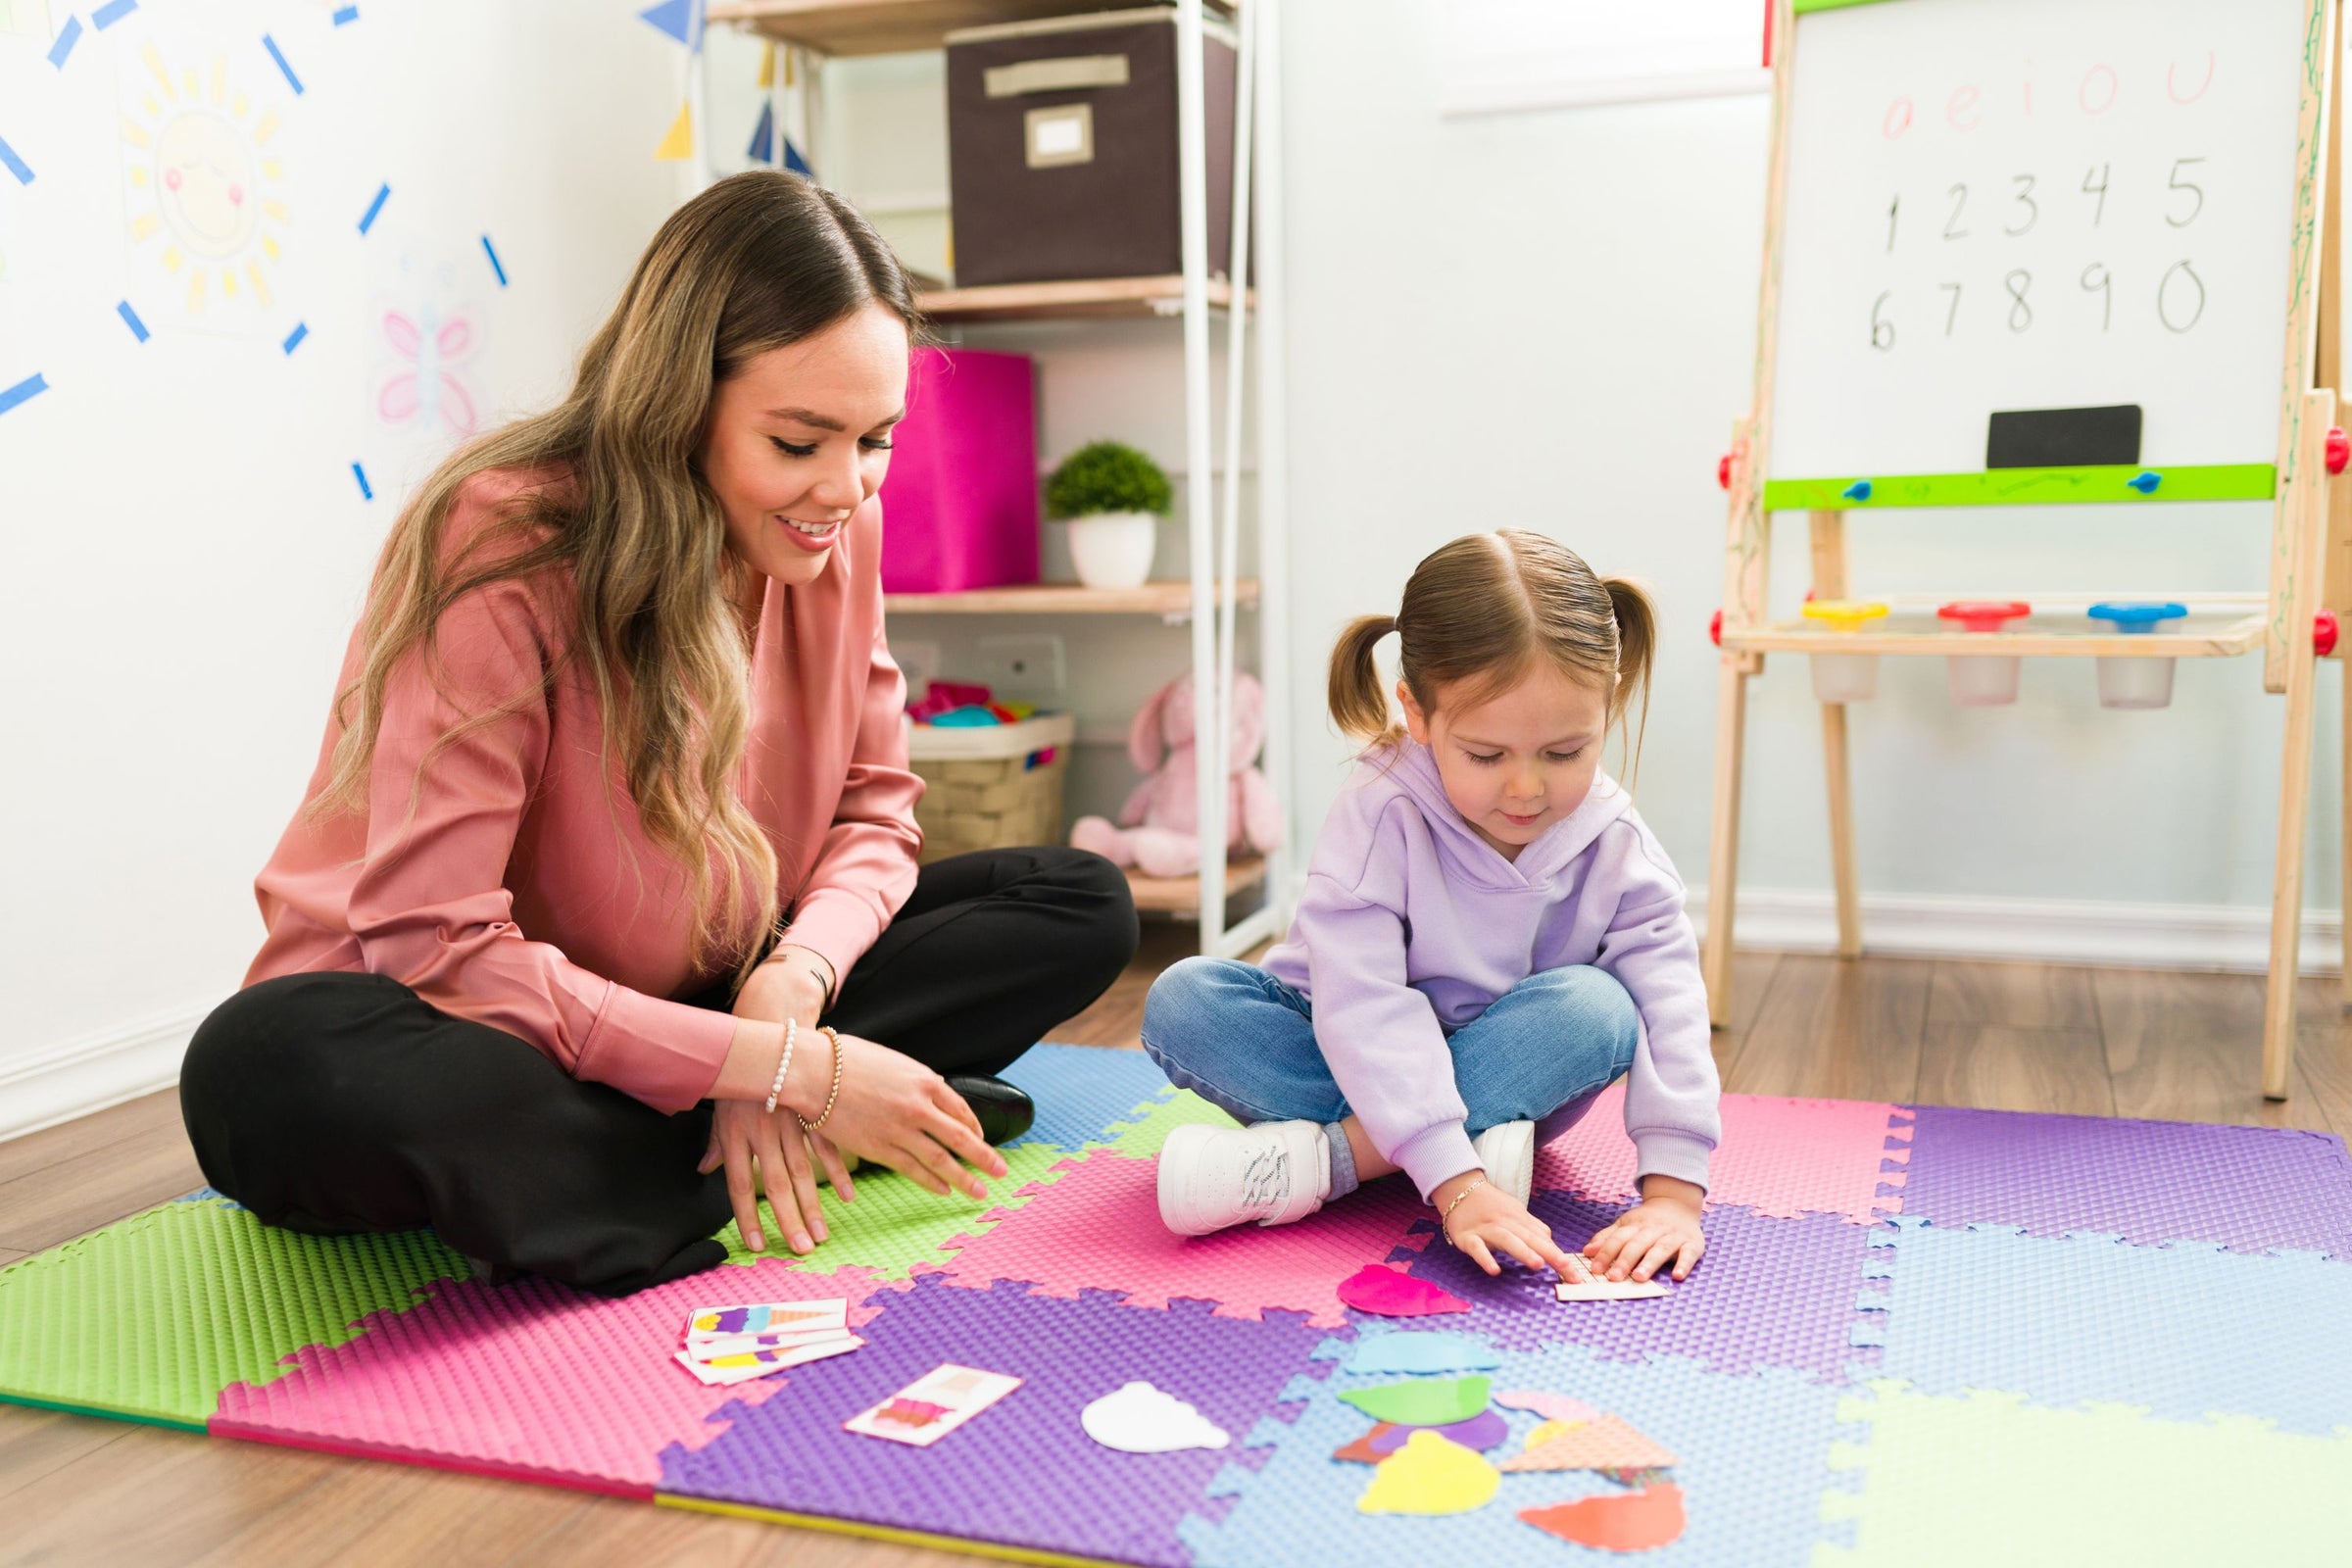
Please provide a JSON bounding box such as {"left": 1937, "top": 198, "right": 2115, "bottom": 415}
{"left": 207, "top": 1257, "right": 882, "bottom": 1497}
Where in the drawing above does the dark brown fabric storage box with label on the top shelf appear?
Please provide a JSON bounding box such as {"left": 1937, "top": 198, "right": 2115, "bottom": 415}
{"left": 948, "top": 7, "right": 1235, "bottom": 287}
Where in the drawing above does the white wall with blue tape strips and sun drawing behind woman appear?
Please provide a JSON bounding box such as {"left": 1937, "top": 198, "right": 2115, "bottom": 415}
{"left": 0, "top": 0, "right": 680, "bottom": 1133}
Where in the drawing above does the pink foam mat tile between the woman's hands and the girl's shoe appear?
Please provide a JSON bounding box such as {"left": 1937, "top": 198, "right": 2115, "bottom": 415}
{"left": 943, "top": 1150, "right": 1428, "bottom": 1328}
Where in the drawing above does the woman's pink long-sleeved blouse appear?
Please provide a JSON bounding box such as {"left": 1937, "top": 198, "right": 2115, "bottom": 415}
{"left": 245, "top": 470, "right": 922, "bottom": 1112}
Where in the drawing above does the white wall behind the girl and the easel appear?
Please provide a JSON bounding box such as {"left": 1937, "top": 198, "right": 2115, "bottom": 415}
{"left": 1284, "top": 0, "right": 2340, "bottom": 961}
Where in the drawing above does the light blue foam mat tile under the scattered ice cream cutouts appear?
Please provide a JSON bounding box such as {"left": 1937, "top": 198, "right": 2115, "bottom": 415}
{"left": 1176, "top": 1345, "right": 1841, "bottom": 1568}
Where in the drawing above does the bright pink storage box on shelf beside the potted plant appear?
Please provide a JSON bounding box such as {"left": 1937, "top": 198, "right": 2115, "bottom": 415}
{"left": 882, "top": 348, "right": 1037, "bottom": 592}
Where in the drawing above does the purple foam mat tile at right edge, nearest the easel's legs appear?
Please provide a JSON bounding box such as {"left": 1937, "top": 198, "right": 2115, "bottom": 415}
{"left": 1903, "top": 1104, "right": 2352, "bottom": 1262}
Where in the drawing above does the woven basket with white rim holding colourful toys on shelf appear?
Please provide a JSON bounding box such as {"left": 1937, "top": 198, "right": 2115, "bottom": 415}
{"left": 907, "top": 712, "right": 1077, "bottom": 865}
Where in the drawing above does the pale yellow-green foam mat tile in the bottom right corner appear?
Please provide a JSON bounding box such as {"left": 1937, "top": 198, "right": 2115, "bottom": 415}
{"left": 1813, "top": 1382, "right": 2352, "bottom": 1568}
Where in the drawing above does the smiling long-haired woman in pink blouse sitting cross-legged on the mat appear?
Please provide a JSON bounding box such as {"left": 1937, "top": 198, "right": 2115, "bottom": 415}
{"left": 181, "top": 172, "right": 1136, "bottom": 1296}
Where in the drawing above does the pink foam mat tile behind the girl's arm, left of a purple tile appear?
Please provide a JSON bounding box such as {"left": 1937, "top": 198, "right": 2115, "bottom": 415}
{"left": 1536, "top": 1084, "right": 1910, "bottom": 1225}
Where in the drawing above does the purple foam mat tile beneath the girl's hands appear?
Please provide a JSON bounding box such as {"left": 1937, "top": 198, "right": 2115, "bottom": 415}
{"left": 1399, "top": 1192, "right": 1872, "bottom": 1382}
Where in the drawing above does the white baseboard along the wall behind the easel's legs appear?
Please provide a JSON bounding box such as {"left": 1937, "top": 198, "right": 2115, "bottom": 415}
{"left": 1691, "top": 889, "right": 2342, "bottom": 976}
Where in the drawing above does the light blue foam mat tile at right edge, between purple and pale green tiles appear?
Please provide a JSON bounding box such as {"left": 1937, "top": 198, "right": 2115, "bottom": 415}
{"left": 1880, "top": 1227, "right": 2352, "bottom": 1434}
